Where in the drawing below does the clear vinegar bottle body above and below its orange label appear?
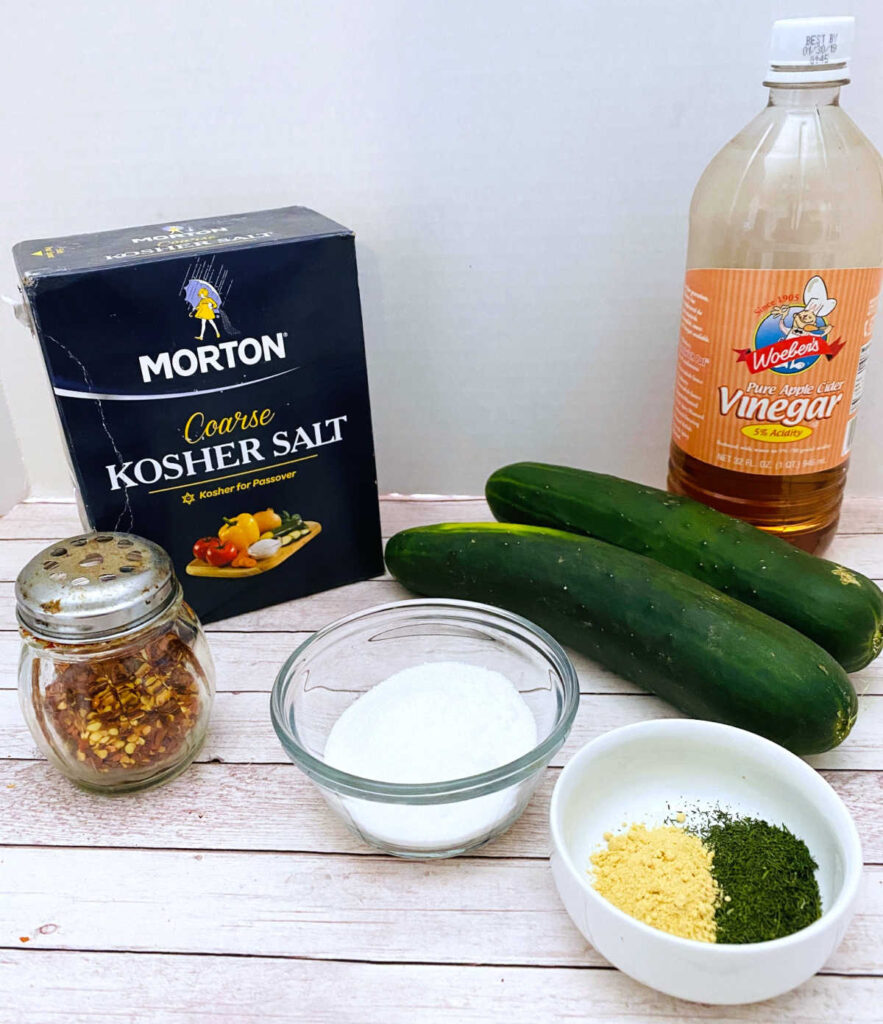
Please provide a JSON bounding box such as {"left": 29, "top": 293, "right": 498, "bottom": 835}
{"left": 668, "top": 19, "right": 883, "bottom": 552}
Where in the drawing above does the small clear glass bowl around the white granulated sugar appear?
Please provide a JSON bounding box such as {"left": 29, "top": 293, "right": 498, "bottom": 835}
{"left": 270, "top": 599, "right": 580, "bottom": 858}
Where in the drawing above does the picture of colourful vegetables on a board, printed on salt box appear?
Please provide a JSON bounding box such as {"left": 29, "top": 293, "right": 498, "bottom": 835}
{"left": 186, "top": 508, "right": 322, "bottom": 580}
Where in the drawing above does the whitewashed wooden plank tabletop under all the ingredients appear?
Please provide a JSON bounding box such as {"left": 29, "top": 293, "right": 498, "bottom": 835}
{"left": 0, "top": 498, "right": 883, "bottom": 1024}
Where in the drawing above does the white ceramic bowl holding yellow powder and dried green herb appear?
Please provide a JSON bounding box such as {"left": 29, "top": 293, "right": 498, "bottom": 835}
{"left": 550, "top": 719, "right": 861, "bottom": 1004}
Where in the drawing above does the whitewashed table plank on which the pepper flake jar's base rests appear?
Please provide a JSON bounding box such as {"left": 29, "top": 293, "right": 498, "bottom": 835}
{"left": 0, "top": 761, "right": 883, "bottom": 864}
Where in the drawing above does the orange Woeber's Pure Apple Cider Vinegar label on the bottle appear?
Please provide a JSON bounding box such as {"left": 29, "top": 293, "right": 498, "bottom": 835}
{"left": 672, "top": 267, "right": 883, "bottom": 476}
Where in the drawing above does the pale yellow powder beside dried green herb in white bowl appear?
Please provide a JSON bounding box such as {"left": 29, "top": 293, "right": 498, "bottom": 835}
{"left": 591, "top": 824, "right": 720, "bottom": 942}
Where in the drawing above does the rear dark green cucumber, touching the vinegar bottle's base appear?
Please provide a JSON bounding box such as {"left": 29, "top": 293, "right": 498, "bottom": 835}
{"left": 486, "top": 462, "right": 883, "bottom": 672}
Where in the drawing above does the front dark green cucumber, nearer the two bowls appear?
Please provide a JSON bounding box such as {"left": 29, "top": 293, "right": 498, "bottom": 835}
{"left": 386, "top": 523, "right": 857, "bottom": 754}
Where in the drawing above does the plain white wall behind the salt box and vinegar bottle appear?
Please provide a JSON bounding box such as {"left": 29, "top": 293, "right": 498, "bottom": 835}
{"left": 0, "top": 0, "right": 883, "bottom": 496}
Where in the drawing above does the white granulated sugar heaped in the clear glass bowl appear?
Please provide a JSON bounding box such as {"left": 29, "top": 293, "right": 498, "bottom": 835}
{"left": 325, "top": 662, "right": 537, "bottom": 849}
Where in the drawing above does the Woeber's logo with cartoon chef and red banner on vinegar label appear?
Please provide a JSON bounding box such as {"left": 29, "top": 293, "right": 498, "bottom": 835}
{"left": 733, "top": 274, "right": 845, "bottom": 375}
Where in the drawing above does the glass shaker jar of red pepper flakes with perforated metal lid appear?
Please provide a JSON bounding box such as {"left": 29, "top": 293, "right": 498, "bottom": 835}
{"left": 15, "top": 532, "right": 214, "bottom": 793}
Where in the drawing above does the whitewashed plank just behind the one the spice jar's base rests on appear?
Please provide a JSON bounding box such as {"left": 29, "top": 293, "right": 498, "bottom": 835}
{"left": 0, "top": 690, "right": 883, "bottom": 771}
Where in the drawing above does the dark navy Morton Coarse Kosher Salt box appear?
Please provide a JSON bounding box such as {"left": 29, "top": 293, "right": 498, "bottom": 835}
{"left": 14, "top": 207, "right": 383, "bottom": 622}
